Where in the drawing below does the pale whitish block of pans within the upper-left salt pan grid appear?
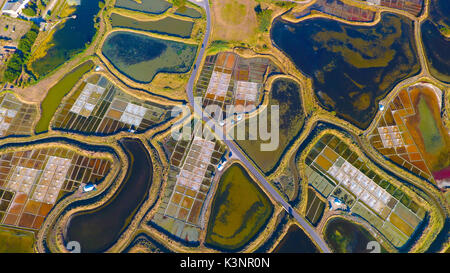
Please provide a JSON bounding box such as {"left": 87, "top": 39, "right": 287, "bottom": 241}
{"left": 70, "top": 83, "right": 105, "bottom": 117}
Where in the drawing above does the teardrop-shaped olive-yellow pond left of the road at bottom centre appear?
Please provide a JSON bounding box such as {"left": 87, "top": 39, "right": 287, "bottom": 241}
{"left": 206, "top": 164, "right": 273, "bottom": 251}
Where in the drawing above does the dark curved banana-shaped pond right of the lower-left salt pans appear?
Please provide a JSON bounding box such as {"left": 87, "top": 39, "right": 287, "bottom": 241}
{"left": 65, "top": 139, "right": 153, "bottom": 252}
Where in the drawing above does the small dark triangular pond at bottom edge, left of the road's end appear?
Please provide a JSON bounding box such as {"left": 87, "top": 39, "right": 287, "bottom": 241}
{"left": 273, "top": 225, "right": 319, "bottom": 253}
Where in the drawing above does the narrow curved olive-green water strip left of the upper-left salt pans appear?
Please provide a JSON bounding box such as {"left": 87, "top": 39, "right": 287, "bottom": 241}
{"left": 35, "top": 61, "right": 94, "bottom": 134}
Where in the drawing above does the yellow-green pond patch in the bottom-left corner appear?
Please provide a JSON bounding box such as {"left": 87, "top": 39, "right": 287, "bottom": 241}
{"left": 0, "top": 227, "right": 34, "bottom": 253}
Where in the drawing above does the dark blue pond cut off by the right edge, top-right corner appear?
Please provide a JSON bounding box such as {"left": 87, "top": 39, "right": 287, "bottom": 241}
{"left": 422, "top": 0, "right": 450, "bottom": 83}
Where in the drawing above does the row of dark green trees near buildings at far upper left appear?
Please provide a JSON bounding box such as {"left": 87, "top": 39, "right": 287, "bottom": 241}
{"left": 4, "top": 24, "right": 39, "bottom": 83}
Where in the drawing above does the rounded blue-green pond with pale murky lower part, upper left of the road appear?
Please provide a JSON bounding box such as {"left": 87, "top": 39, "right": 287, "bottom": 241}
{"left": 102, "top": 31, "right": 197, "bottom": 83}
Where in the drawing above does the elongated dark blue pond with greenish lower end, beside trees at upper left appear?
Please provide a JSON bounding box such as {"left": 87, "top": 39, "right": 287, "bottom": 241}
{"left": 31, "top": 0, "right": 100, "bottom": 77}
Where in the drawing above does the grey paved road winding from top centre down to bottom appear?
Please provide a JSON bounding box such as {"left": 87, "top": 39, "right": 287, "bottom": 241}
{"left": 187, "top": 0, "right": 331, "bottom": 253}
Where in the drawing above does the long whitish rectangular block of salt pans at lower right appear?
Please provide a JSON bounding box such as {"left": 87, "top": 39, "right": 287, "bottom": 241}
{"left": 328, "top": 157, "right": 391, "bottom": 214}
